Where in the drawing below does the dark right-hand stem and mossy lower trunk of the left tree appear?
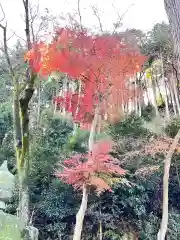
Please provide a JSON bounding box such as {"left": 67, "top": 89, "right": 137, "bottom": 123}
{"left": 18, "top": 76, "right": 36, "bottom": 225}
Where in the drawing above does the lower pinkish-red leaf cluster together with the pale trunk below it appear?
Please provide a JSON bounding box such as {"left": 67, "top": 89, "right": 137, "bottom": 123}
{"left": 56, "top": 140, "right": 126, "bottom": 240}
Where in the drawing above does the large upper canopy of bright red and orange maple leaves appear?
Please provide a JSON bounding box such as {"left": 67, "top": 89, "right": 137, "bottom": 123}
{"left": 25, "top": 29, "right": 146, "bottom": 125}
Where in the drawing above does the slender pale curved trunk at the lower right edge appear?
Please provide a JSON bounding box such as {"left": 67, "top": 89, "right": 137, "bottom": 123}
{"left": 157, "top": 130, "right": 180, "bottom": 240}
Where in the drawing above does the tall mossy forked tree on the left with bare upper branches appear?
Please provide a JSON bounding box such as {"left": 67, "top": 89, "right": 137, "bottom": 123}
{"left": 0, "top": 0, "right": 36, "bottom": 238}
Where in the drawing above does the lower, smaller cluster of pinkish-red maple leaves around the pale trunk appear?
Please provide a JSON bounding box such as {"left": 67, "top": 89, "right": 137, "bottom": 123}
{"left": 56, "top": 140, "right": 125, "bottom": 192}
